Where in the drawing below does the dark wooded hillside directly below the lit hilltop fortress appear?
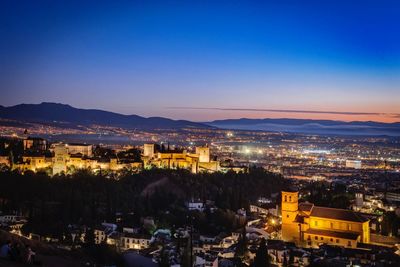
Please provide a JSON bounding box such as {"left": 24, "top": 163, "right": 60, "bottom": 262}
{"left": 0, "top": 169, "right": 285, "bottom": 239}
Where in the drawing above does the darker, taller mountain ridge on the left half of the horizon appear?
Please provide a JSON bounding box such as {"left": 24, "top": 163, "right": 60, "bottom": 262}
{"left": 0, "top": 102, "right": 212, "bottom": 129}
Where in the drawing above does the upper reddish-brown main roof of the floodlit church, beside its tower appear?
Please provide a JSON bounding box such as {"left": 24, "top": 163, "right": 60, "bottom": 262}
{"left": 310, "top": 206, "right": 368, "bottom": 223}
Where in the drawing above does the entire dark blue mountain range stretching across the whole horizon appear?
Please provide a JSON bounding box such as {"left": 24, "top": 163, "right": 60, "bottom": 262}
{"left": 0, "top": 102, "right": 400, "bottom": 136}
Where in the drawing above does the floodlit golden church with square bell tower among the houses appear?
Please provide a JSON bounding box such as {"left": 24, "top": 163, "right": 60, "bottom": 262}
{"left": 282, "top": 192, "right": 370, "bottom": 248}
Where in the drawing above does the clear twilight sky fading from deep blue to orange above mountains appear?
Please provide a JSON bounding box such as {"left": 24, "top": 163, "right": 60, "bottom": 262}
{"left": 0, "top": 0, "right": 400, "bottom": 121}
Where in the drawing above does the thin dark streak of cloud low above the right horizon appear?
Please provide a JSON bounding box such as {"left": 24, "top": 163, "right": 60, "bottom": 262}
{"left": 167, "top": 107, "right": 400, "bottom": 118}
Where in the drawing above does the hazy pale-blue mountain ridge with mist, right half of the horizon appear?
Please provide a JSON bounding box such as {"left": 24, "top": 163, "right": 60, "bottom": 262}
{"left": 205, "top": 118, "right": 400, "bottom": 136}
